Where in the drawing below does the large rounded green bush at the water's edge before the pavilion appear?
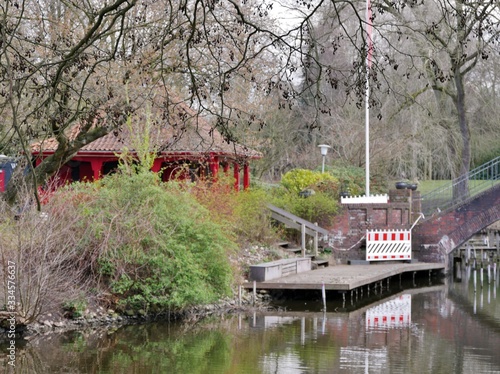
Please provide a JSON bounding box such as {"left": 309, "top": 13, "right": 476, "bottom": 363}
{"left": 67, "top": 171, "right": 235, "bottom": 310}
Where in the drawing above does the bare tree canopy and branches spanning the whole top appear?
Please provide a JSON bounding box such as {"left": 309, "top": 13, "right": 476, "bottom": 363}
{"left": 0, "top": 0, "right": 500, "bottom": 205}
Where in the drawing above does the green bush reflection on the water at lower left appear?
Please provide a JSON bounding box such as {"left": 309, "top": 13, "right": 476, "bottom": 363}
{"left": 6, "top": 324, "right": 234, "bottom": 374}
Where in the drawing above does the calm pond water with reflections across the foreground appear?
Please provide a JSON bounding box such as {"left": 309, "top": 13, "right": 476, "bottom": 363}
{"left": 0, "top": 268, "right": 500, "bottom": 374}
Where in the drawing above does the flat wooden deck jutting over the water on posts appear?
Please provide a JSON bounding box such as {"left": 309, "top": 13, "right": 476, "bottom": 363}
{"left": 243, "top": 262, "right": 445, "bottom": 291}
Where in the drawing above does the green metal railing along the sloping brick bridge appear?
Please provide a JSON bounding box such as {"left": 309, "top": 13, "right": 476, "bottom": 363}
{"left": 422, "top": 156, "right": 500, "bottom": 218}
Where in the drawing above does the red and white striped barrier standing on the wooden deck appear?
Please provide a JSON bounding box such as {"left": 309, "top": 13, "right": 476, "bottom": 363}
{"left": 366, "top": 230, "right": 411, "bottom": 261}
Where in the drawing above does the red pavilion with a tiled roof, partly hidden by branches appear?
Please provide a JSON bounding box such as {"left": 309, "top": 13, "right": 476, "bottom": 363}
{"left": 31, "top": 99, "right": 262, "bottom": 190}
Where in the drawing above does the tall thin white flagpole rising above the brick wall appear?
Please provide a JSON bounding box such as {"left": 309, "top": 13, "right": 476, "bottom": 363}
{"left": 365, "top": 0, "right": 373, "bottom": 197}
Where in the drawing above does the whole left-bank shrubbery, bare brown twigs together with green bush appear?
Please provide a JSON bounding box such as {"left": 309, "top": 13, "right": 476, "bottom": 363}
{"left": 0, "top": 172, "right": 254, "bottom": 322}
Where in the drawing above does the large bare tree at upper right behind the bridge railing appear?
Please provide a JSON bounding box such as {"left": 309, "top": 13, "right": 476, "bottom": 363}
{"left": 375, "top": 0, "right": 500, "bottom": 177}
